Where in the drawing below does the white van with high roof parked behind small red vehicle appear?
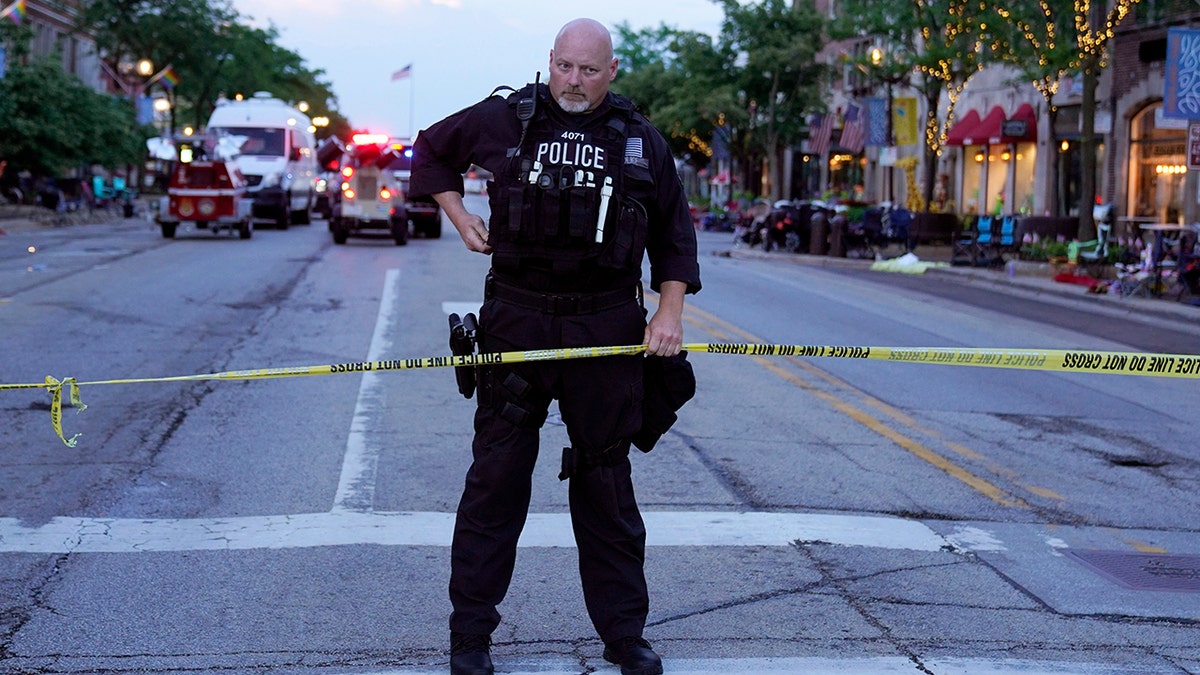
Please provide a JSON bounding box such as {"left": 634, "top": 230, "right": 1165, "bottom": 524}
{"left": 205, "top": 91, "right": 318, "bottom": 229}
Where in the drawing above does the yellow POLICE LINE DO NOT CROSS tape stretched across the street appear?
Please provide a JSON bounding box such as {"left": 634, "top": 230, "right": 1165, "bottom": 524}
{"left": 0, "top": 342, "right": 1200, "bottom": 448}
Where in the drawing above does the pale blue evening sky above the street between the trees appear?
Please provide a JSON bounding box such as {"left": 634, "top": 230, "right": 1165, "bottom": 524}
{"left": 233, "top": 0, "right": 724, "bottom": 137}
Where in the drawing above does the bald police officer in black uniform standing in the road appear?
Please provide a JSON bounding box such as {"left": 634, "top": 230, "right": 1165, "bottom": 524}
{"left": 410, "top": 19, "right": 700, "bottom": 675}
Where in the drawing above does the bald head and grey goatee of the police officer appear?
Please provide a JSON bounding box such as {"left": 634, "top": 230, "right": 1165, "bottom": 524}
{"left": 550, "top": 19, "right": 617, "bottom": 113}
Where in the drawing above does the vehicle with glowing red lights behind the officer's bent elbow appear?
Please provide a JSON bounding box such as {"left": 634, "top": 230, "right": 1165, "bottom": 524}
{"left": 329, "top": 133, "right": 408, "bottom": 246}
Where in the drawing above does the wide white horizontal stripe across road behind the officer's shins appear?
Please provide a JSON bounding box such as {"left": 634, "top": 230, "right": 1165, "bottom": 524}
{"left": 0, "top": 510, "right": 948, "bottom": 554}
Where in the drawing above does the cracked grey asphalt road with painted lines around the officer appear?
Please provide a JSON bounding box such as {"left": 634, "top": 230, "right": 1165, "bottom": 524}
{"left": 0, "top": 206, "right": 1200, "bottom": 675}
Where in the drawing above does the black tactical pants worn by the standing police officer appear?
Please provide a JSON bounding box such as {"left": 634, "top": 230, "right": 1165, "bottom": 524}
{"left": 450, "top": 299, "right": 649, "bottom": 641}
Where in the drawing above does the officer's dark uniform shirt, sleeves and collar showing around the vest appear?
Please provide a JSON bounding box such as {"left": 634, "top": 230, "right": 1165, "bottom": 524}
{"left": 409, "top": 86, "right": 700, "bottom": 293}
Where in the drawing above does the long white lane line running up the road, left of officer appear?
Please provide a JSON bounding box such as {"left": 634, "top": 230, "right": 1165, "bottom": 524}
{"left": 334, "top": 269, "right": 400, "bottom": 512}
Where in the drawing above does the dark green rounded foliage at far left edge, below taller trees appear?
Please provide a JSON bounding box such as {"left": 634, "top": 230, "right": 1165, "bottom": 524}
{"left": 0, "top": 56, "right": 149, "bottom": 175}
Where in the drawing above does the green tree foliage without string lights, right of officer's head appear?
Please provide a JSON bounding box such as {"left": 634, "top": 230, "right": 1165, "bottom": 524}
{"left": 614, "top": 0, "right": 826, "bottom": 198}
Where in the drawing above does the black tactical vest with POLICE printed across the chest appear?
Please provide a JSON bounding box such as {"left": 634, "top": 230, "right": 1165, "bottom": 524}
{"left": 488, "top": 86, "right": 653, "bottom": 282}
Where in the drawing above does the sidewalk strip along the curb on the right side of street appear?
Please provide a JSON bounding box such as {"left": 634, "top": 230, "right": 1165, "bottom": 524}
{"left": 718, "top": 245, "right": 1200, "bottom": 333}
